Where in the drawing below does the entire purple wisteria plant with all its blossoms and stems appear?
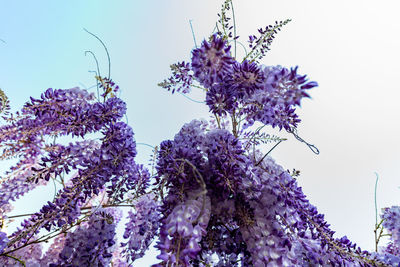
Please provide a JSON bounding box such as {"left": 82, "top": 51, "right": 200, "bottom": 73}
{"left": 0, "top": 0, "right": 400, "bottom": 266}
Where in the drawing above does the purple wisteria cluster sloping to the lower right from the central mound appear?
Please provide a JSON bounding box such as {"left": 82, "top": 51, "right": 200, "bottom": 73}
{"left": 242, "top": 157, "right": 373, "bottom": 266}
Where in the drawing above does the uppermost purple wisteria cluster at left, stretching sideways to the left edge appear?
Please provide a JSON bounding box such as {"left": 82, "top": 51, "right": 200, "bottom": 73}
{"left": 0, "top": 88, "right": 126, "bottom": 142}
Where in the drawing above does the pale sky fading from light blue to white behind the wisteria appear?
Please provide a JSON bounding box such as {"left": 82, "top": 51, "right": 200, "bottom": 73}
{"left": 0, "top": 0, "right": 400, "bottom": 264}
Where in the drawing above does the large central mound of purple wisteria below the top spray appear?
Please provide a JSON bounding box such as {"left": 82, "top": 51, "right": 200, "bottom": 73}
{"left": 157, "top": 120, "right": 379, "bottom": 266}
